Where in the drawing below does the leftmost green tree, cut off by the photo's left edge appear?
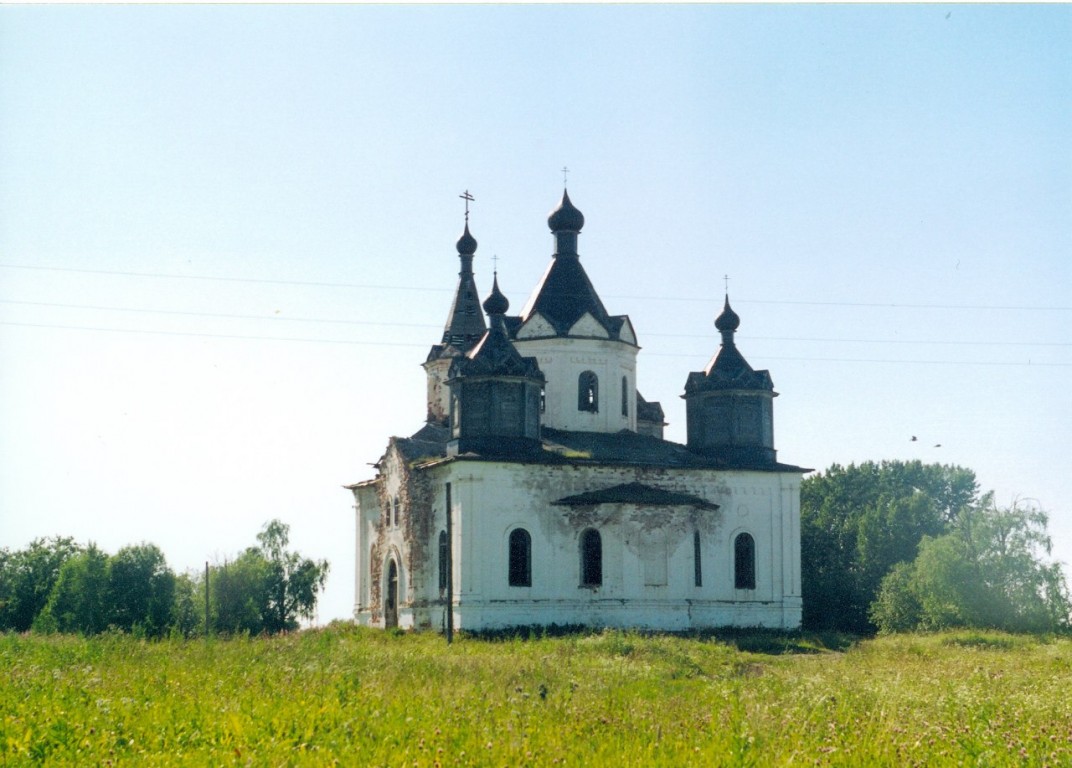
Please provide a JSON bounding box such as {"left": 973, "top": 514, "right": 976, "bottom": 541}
{"left": 0, "top": 536, "right": 81, "bottom": 632}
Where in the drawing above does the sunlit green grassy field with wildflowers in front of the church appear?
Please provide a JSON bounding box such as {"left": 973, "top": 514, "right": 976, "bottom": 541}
{"left": 0, "top": 625, "right": 1072, "bottom": 766}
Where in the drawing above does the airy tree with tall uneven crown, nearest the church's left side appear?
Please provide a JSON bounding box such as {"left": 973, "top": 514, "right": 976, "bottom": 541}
{"left": 257, "top": 520, "right": 329, "bottom": 632}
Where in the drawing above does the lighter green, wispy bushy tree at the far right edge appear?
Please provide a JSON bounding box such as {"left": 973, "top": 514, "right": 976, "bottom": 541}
{"left": 870, "top": 494, "right": 1072, "bottom": 633}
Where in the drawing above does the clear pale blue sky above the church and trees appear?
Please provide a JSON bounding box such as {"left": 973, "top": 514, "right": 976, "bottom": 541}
{"left": 0, "top": 4, "right": 1072, "bottom": 621}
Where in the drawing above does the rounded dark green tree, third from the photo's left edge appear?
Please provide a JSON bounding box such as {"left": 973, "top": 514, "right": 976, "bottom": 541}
{"left": 108, "top": 544, "right": 175, "bottom": 637}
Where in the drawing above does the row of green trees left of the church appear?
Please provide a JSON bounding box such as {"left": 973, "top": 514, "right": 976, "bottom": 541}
{"left": 0, "top": 520, "right": 328, "bottom": 637}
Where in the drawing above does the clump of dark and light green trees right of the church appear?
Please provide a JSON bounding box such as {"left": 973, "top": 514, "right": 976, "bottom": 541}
{"left": 801, "top": 461, "right": 1072, "bottom": 634}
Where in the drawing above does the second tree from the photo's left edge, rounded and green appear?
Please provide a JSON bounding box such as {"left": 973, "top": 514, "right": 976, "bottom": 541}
{"left": 33, "top": 543, "right": 109, "bottom": 635}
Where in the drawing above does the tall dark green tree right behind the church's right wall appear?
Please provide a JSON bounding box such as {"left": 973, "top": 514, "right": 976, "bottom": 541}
{"left": 801, "top": 461, "right": 978, "bottom": 632}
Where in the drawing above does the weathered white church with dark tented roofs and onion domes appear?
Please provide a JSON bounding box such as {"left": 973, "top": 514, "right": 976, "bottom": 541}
{"left": 345, "top": 191, "right": 810, "bottom": 632}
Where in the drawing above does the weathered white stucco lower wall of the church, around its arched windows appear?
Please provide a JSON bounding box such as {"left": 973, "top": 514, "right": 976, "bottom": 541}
{"left": 356, "top": 461, "right": 801, "bottom": 630}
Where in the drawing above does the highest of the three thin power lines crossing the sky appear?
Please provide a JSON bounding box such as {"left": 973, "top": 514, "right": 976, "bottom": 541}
{"left": 0, "top": 264, "right": 1072, "bottom": 312}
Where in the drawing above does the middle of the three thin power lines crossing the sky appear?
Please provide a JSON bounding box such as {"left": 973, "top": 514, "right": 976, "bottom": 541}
{"left": 0, "top": 299, "right": 1072, "bottom": 346}
